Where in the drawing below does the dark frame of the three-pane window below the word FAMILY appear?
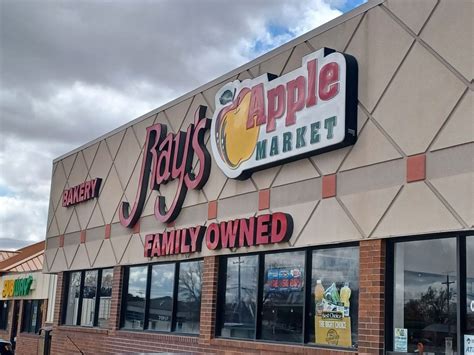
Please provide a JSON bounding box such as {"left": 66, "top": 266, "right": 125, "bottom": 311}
{"left": 120, "top": 258, "right": 204, "bottom": 337}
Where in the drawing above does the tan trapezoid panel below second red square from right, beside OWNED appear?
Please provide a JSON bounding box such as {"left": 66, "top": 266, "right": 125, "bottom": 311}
{"left": 298, "top": 198, "right": 362, "bottom": 245}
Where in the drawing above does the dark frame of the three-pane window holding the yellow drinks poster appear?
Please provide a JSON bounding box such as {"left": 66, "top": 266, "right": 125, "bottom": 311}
{"left": 214, "top": 242, "right": 360, "bottom": 351}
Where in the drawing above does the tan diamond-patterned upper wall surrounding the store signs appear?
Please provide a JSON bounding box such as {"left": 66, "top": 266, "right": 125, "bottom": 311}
{"left": 45, "top": 0, "right": 474, "bottom": 272}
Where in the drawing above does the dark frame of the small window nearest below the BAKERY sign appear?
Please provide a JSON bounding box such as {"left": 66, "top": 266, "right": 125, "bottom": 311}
{"left": 61, "top": 267, "right": 114, "bottom": 329}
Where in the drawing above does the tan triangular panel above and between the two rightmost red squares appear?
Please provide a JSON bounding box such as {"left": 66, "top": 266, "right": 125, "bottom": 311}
{"left": 341, "top": 121, "right": 401, "bottom": 171}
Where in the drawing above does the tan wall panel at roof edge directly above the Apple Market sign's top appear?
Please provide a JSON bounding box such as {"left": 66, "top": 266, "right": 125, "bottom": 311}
{"left": 308, "top": 15, "right": 362, "bottom": 54}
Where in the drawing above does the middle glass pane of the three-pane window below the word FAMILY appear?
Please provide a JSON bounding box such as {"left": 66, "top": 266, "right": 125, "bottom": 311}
{"left": 148, "top": 264, "right": 175, "bottom": 331}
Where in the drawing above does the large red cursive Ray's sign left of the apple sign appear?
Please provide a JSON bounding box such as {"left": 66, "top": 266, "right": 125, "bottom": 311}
{"left": 119, "top": 106, "right": 211, "bottom": 228}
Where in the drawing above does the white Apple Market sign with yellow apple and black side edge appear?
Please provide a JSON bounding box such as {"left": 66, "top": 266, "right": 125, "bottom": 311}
{"left": 211, "top": 48, "right": 358, "bottom": 179}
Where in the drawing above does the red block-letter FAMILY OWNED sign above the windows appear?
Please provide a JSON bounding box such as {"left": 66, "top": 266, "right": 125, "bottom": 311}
{"left": 144, "top": 212, "right": 293, "bottom": 258}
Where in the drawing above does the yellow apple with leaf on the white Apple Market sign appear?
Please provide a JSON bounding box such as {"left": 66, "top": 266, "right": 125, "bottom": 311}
{"left": 215, "top": 88, "right": 260, "bottom": 169}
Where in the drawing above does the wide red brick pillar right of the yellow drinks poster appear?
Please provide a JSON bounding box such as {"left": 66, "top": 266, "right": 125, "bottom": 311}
{"left": 359, "top": 239, "right": 386, "bottom": 354}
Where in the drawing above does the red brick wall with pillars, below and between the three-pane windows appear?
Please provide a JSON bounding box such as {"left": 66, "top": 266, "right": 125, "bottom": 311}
{"left": 52, "top": 249, "right": 385, "bottom": 355}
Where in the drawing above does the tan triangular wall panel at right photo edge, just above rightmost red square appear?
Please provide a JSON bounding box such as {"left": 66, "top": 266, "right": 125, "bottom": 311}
{"left": 431, "top": 91, "right": 474, "bottom": 151}
